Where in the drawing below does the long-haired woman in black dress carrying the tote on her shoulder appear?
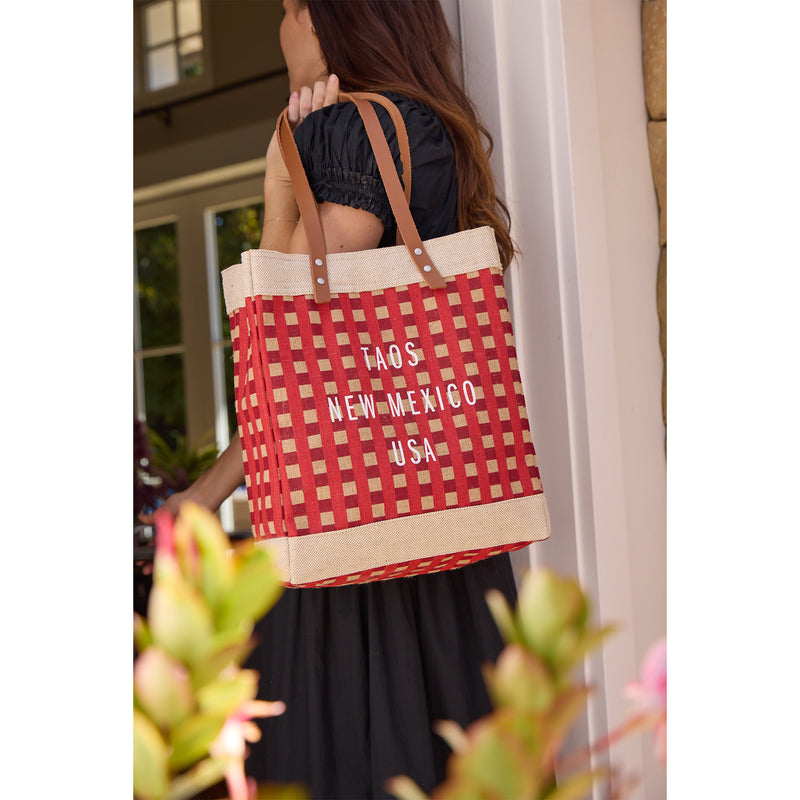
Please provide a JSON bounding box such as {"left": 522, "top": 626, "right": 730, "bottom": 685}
{"left": 148, "top": 0, "right": 515, "bottom": 798}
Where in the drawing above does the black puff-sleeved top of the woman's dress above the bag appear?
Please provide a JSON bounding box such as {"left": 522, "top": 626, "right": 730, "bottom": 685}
{"left": 295, "top": 93, "right": 457, "bottom": 245}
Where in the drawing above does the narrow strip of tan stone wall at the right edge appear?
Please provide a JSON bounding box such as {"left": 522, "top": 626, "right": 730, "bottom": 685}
{"left": 642, "top": 0, "right": 667, "bottom": 425}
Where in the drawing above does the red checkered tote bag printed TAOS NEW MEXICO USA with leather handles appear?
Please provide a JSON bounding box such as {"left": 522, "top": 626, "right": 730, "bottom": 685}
{"left": 222, "top": 93, "right": 550, "bottom": 587}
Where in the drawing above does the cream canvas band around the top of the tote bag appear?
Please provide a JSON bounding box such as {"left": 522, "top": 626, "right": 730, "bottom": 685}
{"left": 222, "top": 226, "right": 502, "bottom": 315}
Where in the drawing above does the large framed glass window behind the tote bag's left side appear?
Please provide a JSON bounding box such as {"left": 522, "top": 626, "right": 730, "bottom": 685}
{"left": 133, "top": 167, "right": 264, "bottom": 532}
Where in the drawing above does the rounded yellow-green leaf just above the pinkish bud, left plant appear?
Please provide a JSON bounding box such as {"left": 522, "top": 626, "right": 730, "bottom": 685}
{"left": 148, "top": 581, "right": 214, "bottom": 665}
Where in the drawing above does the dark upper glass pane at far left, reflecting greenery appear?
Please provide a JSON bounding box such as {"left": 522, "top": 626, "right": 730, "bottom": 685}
{"left": 135, "top": 222, "right": 181, "bottom": 349}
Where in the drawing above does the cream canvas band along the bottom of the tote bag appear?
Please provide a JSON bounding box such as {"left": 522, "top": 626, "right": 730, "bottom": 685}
{"left": 257, "top": 494, "right": 550, "bottom": 585}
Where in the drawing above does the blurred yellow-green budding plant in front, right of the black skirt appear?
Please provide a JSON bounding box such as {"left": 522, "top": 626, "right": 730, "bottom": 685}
{"left": 387, "top": 570, "right": 612, "bottom": 800}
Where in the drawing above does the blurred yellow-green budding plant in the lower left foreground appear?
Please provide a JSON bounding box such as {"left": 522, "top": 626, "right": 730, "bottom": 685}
{"left": 133, "top": 503, "right": 306, "bottom": 800}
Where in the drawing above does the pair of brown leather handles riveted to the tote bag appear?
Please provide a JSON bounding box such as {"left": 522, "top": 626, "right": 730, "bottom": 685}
{"left": 277, "top": 92, "right": 445, "bottom": 303}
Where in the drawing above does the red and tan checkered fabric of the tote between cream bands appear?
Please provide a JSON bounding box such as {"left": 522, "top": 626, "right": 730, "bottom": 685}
{"left": 230, "top": 269, "right": 542, "bottom": 585}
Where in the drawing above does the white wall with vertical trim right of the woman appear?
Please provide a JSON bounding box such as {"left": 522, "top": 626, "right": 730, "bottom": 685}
{"left": 459, "top": 0, "right": 666, "bottom": 800}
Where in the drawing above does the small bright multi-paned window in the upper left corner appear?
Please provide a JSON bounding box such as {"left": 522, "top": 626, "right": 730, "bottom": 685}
{"left": 140, "top": 0, "right": 204, "bottom": 92}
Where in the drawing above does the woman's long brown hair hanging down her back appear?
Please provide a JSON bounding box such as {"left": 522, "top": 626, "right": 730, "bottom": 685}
{"left": 299, "top": 0, "right": 515, "bottom": 269}
